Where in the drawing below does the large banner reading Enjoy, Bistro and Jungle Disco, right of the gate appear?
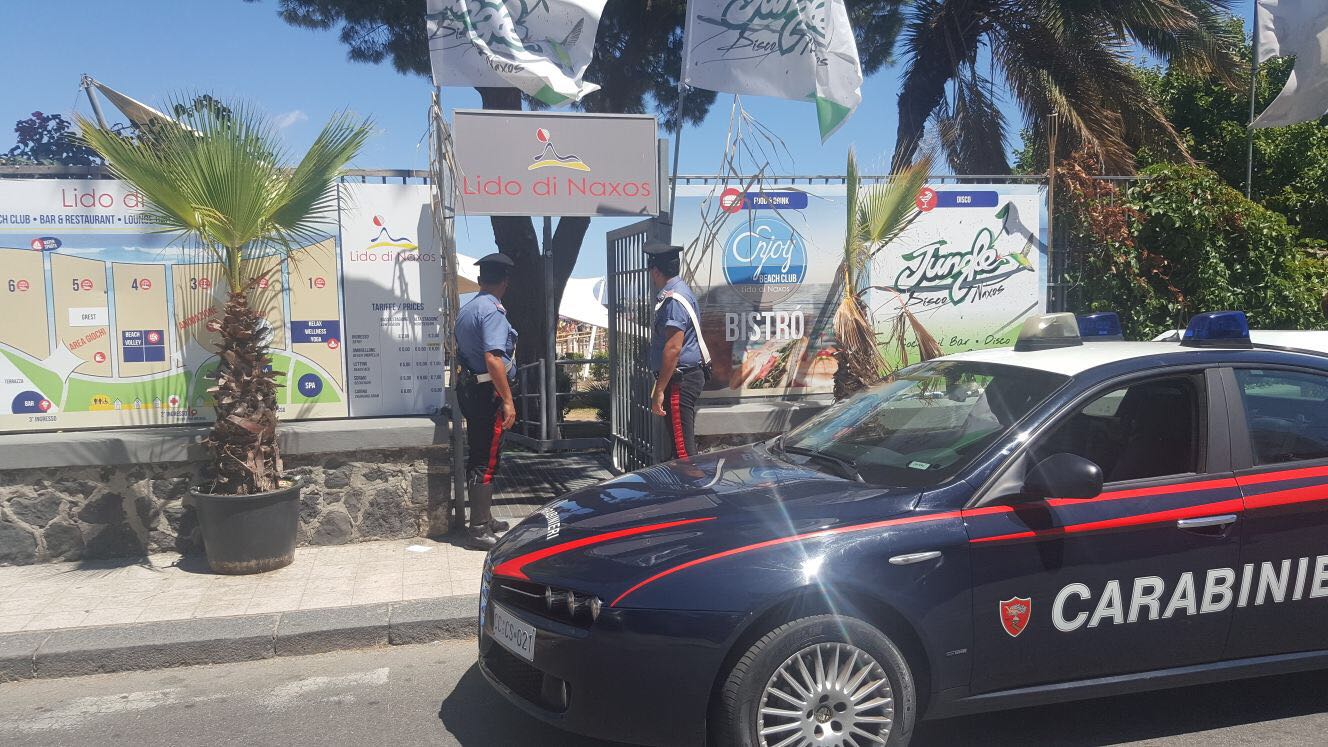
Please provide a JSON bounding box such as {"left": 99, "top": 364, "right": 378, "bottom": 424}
{"left": 673, "top": 183, "right": 1046, "bottom": 399}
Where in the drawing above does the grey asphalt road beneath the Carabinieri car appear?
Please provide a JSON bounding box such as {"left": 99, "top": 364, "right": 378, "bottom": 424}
{"left": 0, "top": 632, "right": 1328, "bottom": 747}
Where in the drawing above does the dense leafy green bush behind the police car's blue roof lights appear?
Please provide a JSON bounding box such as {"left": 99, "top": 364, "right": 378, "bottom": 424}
{"left": 1065, "top": 163, "right": 1328, "bottom": 339}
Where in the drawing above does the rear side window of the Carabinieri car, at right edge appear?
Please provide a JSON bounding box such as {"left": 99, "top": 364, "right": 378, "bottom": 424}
{"left": 1236, "top": 368, "right": 1328, "bottom": 465}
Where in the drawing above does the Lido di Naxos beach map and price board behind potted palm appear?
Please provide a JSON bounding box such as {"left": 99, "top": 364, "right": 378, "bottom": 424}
{"left": 0, "top": 179, "right": 442, "bottom": 432}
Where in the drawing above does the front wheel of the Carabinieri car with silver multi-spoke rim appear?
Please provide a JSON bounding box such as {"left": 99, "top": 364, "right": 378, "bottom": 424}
{"left": 710, "top": 614, "right": 918, "bottom": 747}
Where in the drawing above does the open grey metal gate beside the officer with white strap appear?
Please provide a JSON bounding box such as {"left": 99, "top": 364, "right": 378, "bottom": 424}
{"left": 607, "top": 219, "right": 669, "bottom": 472}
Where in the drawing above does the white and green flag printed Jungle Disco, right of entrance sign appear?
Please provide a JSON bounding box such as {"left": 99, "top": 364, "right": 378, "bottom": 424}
{"left": 683, "top": 0, "right": 862, "bottom": 141}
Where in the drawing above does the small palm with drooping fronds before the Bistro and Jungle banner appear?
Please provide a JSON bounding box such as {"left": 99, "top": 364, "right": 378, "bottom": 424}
{"left": 834, "top": 150, "right": 940, "bottom": 400}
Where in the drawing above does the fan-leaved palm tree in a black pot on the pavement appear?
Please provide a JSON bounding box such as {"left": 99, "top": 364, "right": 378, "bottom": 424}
{"left": 78, "top": 101, "right": 369, "bottom": 574}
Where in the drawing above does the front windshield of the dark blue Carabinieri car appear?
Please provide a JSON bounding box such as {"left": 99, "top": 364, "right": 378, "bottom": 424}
{"left": 776, "top": 360, "right": 1069, "bottom": 488}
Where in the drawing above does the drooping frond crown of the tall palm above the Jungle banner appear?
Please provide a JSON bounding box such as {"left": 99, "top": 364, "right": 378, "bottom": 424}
{"left": 894, "top": 0, "right": 1243, "bottom": 174}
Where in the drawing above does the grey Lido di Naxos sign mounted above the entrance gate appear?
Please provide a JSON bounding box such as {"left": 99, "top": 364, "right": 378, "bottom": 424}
{"left": 452, "top": 109, "right": 661, "bottom": 217}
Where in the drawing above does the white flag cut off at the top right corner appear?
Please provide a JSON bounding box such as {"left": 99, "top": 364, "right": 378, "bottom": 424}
{"left": 1254, "top": 0, "right": 1328, "bottom": 128}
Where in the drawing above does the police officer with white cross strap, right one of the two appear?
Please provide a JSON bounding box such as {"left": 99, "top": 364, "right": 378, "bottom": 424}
{"left": 644, "top": 243, "right": 709, "bottom": 459}
